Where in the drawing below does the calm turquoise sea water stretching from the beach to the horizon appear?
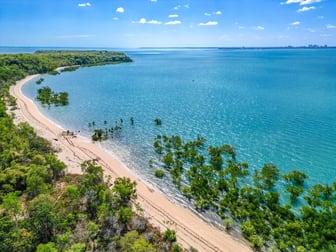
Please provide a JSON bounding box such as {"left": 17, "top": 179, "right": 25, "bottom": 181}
{"left": 23, "top": 49, "right": 336, "bottom": 195}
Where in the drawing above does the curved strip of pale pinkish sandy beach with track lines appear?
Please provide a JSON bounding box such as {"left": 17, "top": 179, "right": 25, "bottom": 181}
{"left": 10, "top": 75, "right": 251, "bottom": 251}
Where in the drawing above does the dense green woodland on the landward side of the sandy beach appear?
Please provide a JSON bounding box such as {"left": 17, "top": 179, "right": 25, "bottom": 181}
{"left": 0, "top": 52, "right": 181, "bottom": 252}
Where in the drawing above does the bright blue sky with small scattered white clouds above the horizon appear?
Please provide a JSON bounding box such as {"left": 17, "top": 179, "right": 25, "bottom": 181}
{"left": 0, "top": 0, "right": 336, "bottom": 48}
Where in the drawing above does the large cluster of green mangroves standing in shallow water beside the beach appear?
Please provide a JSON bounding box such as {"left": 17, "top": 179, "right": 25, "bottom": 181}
{"left": 149, "top": 135, "right": 336, "bottom": 251}
